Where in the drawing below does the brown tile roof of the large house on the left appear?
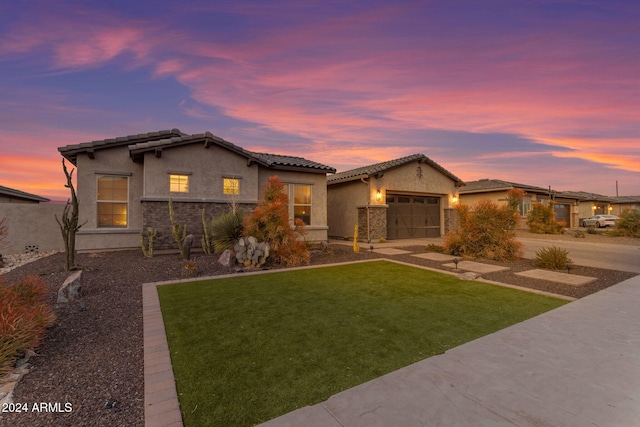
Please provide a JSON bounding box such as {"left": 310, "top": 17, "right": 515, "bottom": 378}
{"left": 58, "top": 129, "right": 336, "bottom": 173}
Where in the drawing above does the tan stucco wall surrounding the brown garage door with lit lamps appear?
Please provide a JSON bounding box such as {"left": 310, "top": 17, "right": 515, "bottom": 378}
{"left": 327, "top": 161, "right": 459, "bottom": 241}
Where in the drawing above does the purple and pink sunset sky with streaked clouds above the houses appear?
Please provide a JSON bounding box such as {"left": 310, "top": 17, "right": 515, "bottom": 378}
{"left": 0, "top": 0, "right": 640, "bottom": 200}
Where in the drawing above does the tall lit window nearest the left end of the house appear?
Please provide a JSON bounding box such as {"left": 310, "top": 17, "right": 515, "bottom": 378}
{"left": 97, "top": 176, "right": 129, "bottom": 227}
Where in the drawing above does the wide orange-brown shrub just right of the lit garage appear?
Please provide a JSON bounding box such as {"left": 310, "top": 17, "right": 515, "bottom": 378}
{"left": 444, "top": 200, "right": 522, "bottom": 261}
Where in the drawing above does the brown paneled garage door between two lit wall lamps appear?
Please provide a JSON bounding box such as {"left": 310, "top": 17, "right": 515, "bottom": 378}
{"left": 387, "top": 194, "right": 440, "bottom": 239}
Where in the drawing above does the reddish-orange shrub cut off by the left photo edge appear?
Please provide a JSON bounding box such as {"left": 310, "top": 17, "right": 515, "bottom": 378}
{"left": 0, "top": 276, "right": 55, "bottom": 376}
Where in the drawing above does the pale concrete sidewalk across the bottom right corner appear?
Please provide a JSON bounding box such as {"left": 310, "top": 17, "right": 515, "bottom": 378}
{"left": 262, "top": 276, "right": 640, "bottom": 427}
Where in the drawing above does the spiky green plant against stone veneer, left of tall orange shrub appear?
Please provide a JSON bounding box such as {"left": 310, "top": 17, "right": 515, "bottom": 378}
{"left": 202, "top": 209, "right": 244, "bottom": 254}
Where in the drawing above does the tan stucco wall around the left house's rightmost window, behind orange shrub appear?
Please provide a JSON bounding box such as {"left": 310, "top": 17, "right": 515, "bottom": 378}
{"left": 258, "top": 167, "right": 328, "bottom": 242}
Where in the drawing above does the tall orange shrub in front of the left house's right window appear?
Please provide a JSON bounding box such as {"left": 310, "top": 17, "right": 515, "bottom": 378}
{"left": 243, "top": 176, "right": 311, "bottom": 266}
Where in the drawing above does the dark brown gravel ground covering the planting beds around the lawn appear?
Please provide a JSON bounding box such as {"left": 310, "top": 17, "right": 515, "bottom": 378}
{"left": 0, "top": 235, "right": 638, "bottom": 426}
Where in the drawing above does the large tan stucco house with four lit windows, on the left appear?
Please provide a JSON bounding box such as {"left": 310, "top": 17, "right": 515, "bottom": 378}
{"left": 58, "top": 129, "right": 335, "bottom": 250}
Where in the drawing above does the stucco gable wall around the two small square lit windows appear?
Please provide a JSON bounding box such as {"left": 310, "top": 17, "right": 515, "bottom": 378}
{"left": 144, "top": 144, "right": 258, "bottom": 203}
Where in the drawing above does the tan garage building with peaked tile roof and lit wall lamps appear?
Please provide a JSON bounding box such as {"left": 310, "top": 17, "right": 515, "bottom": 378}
{"left": 327, "top": 154, "right": 464, "bottom": 241}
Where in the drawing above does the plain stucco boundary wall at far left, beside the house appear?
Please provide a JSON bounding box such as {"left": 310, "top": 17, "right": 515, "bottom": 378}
{"left": 0, "top": 203, "right": 64, "bottom": 254}
